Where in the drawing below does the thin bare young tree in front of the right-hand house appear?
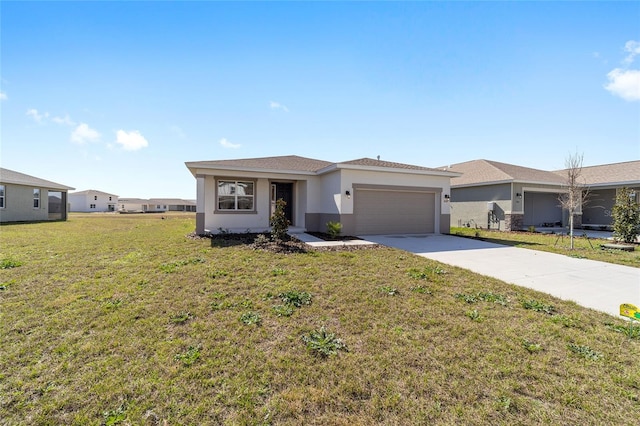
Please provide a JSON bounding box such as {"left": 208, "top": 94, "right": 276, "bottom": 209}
{"left": 558, "top": 152, "right": 588, "bottom": 250}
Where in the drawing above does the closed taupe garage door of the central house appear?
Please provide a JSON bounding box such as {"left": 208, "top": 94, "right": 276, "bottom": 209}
{"left": 353, "top": 189, "right": 435, "bottom": 235}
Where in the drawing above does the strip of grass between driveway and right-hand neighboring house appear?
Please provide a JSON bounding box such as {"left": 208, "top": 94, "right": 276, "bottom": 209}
{"left": 451, "top": 228, "right": 640, "bottom": 268}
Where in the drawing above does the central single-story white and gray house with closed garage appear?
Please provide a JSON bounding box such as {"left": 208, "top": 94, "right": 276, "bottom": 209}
{"left": 186, "top": 156, "right": 458, "bottom": 235}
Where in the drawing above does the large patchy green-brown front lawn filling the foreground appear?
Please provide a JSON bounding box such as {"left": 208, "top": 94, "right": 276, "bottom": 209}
{"left": 0, "top": 215, "right": 640, "bottom": 425}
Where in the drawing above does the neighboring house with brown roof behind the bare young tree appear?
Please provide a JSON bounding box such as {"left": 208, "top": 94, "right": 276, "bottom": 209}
{"left": 444, "top": 160, "right": 640, "bottom": 231}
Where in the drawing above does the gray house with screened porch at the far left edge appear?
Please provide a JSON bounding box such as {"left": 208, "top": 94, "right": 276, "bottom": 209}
{"left": 0, "top": 168, "right": 75, "bottom": 223}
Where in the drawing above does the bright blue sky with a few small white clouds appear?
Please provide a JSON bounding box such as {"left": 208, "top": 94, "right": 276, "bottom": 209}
{"left": 0, "top": 1, "right": 640, "bottom": 198}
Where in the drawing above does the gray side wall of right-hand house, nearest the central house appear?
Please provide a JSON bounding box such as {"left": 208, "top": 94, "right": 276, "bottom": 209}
{"left": 450, "top": 183, "right": 513, "bottom": 230}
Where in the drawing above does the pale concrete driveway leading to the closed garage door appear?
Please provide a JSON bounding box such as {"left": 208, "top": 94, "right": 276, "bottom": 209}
{"left": 360, "top": 234, "right": 640, "bottom": 318}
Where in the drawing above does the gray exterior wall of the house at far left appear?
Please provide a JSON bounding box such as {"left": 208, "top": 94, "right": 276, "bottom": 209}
{"left": 0, "top": 183, "right": 67, "bottom": 223}
